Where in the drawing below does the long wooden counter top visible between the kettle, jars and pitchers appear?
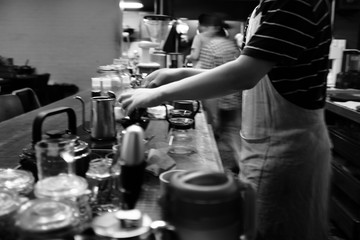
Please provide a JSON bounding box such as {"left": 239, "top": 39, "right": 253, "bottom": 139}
{"left": 0, "top": 91, "right": 223, "bottom": 220}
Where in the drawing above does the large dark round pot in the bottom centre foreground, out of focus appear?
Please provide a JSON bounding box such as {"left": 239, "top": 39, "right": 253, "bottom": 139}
{"left": 159, "top": 170, "right": 255, "bottom": 240}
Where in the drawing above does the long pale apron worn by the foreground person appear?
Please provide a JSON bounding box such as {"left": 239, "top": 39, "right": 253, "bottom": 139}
{"left": 240, "top": 7, "right": 331, "bottom": 240}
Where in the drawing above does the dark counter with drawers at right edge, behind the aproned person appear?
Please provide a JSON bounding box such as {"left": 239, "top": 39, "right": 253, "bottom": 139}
{"left": 325, "top": 98, "right": 360, "bottom": 240}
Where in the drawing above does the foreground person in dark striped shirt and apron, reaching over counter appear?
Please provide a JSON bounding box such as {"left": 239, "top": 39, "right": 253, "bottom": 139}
{"left": 120, "top": 0, "right": 332, "bottom": 240}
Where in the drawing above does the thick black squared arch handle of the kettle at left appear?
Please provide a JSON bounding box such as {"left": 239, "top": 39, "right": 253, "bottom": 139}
{"left": 32, "top": 107, "right": 76, "bottom": 144}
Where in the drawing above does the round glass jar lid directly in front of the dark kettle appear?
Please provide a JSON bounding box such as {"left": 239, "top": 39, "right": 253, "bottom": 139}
{"left": 34, "top": 174, "right": 88, "bottom": 199}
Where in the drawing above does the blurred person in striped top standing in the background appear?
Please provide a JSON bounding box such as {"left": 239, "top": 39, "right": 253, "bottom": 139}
{"left": 197, "top": 13, "right": 241, "bottom": 173}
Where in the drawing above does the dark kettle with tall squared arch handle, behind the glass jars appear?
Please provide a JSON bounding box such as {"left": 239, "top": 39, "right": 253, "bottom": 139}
{"left": 19, "top": 107, "right": 91, "bottom": 181}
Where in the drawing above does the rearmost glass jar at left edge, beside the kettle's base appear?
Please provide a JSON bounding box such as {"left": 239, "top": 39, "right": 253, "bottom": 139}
{"left": 0, "top": 168, "right": 35, "bottom": 198}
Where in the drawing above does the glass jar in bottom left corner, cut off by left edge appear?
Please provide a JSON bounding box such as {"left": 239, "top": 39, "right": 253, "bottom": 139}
{"left": 0, "top": 188, "right": 20, "bottom": 240}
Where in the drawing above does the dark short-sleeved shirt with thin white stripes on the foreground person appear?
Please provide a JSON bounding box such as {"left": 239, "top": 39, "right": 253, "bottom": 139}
{"left": 242, "top": 0, "right": 332, "bottom": 109}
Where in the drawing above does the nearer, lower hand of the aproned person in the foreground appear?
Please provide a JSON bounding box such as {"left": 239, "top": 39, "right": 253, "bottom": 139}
{"left": 119, "top": 88, "right": 162, "bottom": 116}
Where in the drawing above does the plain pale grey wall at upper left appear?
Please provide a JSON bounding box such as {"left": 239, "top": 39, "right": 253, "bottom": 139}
{"left": 0, "top": 0, "right": 120, "bottom": 89}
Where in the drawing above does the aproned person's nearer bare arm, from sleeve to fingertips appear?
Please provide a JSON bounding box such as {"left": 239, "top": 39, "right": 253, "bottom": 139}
{"left": 120, "top": 55, "right": 274, "bottom": 112}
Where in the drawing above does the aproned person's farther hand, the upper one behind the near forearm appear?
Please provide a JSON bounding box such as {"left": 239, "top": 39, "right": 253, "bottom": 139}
{"left": 142, "top": 68, "right": 183, "bottom": 88}
